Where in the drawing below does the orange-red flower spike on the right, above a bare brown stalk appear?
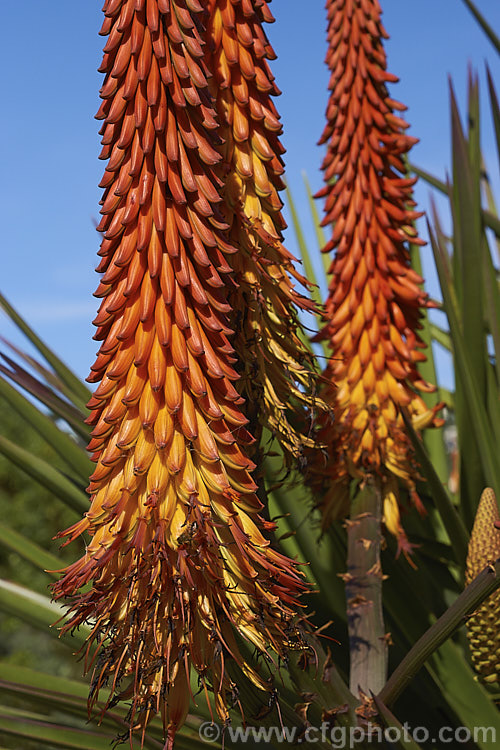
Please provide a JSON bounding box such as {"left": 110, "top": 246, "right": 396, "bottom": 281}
{"left": 312, "top": 0, "right": 444, "bottom": 548}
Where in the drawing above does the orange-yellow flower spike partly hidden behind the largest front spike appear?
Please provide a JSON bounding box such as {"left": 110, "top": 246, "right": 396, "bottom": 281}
{"left": 207, "top": 0, "right": 318, "bottom": 468}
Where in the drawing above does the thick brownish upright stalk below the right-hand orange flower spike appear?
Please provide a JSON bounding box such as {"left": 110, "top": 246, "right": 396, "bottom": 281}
{"left": 344, "top": 484, "right": 387, "bottom": 695}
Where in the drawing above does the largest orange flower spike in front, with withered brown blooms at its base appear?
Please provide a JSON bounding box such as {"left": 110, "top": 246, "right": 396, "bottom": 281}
{"left": 54, "top": 0, "right": 304, "bottom": 747}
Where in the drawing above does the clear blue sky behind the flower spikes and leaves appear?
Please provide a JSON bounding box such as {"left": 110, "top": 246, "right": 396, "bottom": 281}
{"left": 0, "top": 0, "right": 500, "bottom": 388}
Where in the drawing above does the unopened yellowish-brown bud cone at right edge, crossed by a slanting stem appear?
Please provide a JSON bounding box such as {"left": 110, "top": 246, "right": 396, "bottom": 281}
{"left": 465, "top": 487, "right": 500, "bottom": 684}
